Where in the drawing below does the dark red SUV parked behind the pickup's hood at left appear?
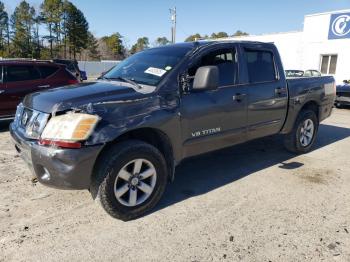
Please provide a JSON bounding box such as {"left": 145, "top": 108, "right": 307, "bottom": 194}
{"left": 0, "top": 60, "right": 78, "bottom": 120}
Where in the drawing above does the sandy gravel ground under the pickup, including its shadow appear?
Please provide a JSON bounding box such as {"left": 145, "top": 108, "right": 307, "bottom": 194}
{"left": 0, "top": 109, "right": 350, "bottom": 261}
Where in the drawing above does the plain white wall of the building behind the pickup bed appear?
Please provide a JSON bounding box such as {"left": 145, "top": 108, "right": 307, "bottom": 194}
{"left": 223, "top": 10, "right": 350, "bottom": 83}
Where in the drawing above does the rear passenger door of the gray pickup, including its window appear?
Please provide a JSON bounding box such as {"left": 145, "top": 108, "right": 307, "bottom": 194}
{"left": 242, "top": 44, "right": 288, "bottom": 140}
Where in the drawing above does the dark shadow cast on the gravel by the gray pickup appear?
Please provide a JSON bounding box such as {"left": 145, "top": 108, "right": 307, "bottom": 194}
{"left": 153, "top": 125, "right": 350, "bottom": 212}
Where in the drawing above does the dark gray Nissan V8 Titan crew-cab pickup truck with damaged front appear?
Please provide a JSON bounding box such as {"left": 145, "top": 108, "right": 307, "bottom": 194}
{"left": 10, "top": 41, "right": 335, "bottom": 220}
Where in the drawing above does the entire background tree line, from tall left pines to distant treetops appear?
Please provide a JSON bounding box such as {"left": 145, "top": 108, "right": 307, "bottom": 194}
{"left": 0, "top": 0, "right": 247, "bottom": 60}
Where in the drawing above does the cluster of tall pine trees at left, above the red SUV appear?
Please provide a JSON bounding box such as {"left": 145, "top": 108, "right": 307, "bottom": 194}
{"left": 0, "top": 0, "right": 92, "bottom": 58}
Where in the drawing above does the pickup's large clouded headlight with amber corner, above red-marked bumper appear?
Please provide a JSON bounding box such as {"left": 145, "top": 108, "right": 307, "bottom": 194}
{"left": 41, "top": 113, "right": 100, "bottom": 142}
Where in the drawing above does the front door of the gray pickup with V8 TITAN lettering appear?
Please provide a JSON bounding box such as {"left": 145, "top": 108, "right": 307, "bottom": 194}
{"left": 180, "top": 45, "right": 247, "bottom": 157}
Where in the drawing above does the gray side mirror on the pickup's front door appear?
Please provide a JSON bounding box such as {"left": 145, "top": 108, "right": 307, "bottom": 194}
{"left": 193, "top": 66, "right": 219, "bottom": 90}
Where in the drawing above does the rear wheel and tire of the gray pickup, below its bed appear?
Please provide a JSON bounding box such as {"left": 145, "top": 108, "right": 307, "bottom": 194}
{"left": 284, "top": 109, "right": 319, "bottom": 154}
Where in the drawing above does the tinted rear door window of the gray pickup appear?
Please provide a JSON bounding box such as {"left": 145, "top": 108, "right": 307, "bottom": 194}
{"left": 245, "top": 50, "right": 276, "bottom": 83}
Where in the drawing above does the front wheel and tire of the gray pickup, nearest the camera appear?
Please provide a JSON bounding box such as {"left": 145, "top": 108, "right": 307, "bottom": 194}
{"left": 90, "top": 140, "right": 168, "bottom": 221}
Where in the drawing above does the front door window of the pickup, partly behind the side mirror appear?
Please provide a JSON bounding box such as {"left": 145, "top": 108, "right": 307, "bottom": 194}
{"left": 188, "top": 49, "right": 237, "bottom": 86}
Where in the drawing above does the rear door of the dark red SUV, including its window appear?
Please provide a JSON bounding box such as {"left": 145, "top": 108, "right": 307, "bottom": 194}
{"left": 2, "top": 65, "right": 41, "bottom": 115}
